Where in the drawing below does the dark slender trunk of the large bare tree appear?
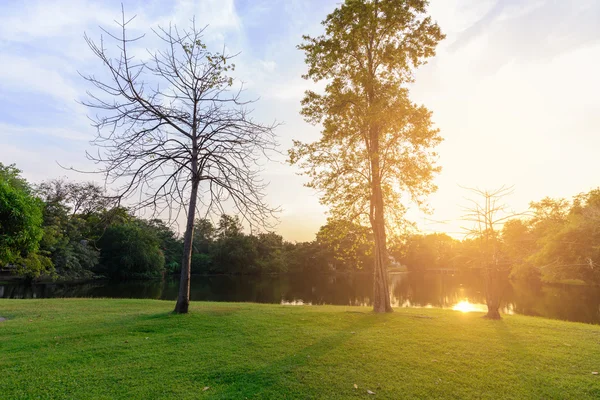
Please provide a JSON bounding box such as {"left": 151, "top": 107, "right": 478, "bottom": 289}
{"left": 174, "top": 178, "right": 200, "bottom": 314}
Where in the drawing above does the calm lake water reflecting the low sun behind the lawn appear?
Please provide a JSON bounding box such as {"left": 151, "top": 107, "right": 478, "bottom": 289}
{"left": 0, "top": 273, "right": 600, "bottom": 324}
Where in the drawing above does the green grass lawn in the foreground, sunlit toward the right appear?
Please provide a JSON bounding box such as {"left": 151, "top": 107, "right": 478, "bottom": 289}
{"left": 0, "top": 299, "right": 600, "bottom": 399}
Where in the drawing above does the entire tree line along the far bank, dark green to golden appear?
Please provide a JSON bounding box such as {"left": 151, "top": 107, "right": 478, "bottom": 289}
{"left": 0, "top": 159, "right": 600, "bottom": 285}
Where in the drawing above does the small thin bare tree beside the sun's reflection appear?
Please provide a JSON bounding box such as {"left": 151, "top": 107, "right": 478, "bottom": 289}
{"left": 463, "top": 186, "right": 520, "bottom": 319}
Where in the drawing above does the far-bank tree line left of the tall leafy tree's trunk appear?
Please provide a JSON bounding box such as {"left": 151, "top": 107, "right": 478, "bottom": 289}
{"left": 0, "top": 163, "right": 372, "bottom": 280}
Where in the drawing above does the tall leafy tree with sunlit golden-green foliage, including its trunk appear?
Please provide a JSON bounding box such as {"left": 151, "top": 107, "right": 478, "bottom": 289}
{"left": 290, "top": 0, "right": 444, "bottom": 312}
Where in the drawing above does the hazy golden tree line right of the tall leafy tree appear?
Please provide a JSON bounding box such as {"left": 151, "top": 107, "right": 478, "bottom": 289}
{"left": 394, "top": 189, "right": 600, "bottom": 285}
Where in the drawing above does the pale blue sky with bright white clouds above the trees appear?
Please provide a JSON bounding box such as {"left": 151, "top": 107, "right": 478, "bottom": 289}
{"left": 0, "top": 0, "right": 600, "bottom": 241}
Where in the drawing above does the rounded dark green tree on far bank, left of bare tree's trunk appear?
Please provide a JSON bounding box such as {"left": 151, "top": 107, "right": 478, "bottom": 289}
{"left": 98, "top": 222, "right": 165, "bottom": 279}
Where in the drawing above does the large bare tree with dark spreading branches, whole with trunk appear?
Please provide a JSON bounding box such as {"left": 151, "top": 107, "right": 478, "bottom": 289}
{"left": 77, "top": 12, "right": 277, "bottom": 313}
